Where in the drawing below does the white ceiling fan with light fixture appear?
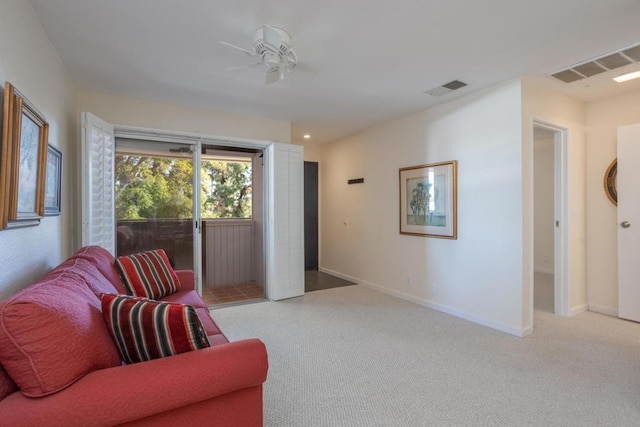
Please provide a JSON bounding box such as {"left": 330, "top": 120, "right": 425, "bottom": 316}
{"left": 218, "top": 25, "right": 316, "bottom": 84}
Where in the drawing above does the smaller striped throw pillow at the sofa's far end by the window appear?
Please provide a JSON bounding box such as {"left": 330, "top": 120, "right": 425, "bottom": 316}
{"left": 116, "top": 249, "right": 180, "bottom": 299}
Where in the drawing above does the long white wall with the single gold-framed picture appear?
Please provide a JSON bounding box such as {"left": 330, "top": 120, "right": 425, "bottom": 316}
{"left": 320, "top": 81, "right": 525, "bottom": 335}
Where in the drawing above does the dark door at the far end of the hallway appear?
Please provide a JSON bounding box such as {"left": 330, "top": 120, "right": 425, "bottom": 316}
{"left": 304, "top": 162, "right": 318, "bottom": 270}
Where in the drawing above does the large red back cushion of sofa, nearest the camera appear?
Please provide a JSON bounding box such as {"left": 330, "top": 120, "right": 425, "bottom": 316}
{"left": 0, "top": 271, "right": 122, "bottom": 397}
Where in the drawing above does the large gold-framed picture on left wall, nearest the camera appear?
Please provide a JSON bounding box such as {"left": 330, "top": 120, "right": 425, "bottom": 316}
{"left": 0, "top": 82, "right": 49, "bottom": 230}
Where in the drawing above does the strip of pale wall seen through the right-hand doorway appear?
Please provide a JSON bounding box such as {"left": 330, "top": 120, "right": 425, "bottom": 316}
{"left": 533, "top": 135, "right": 554, "bottom": 273}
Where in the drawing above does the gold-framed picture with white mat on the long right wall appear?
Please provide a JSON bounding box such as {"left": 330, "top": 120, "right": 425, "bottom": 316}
{"left": 400, "top": 160, "right": 457, "bottom": 239}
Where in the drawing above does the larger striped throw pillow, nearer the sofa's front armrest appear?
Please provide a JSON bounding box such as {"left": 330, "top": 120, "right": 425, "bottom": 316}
{"left": 100, "top": 294, "right": 211, "bottom": 363}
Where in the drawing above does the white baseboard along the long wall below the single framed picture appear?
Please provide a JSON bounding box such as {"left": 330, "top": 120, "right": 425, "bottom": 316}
{"left": 319, "top": 267, "right": 533, "bottom": 337}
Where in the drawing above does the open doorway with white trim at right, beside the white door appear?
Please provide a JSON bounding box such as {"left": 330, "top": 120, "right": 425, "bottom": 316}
{"left": 531, "top": 122, "right": 569, "bottom": 316}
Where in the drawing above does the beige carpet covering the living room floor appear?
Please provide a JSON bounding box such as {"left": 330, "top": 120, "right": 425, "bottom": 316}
{"left": 212, "top": 285, "right": 640, "bottom": 427}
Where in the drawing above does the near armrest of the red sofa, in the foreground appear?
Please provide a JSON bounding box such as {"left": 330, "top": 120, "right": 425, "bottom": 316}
{"left": 0, "top": 339, "right": 268, "bottom": 426}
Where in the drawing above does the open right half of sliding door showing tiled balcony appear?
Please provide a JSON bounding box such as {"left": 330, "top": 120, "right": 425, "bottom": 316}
{"left": 200, "top": 144, "right": 265, "bottom": 306}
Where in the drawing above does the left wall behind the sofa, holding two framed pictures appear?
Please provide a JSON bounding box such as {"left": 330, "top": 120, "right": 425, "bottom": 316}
{"left": 0, "top": 0, "right": 77, "bottom": 299}
